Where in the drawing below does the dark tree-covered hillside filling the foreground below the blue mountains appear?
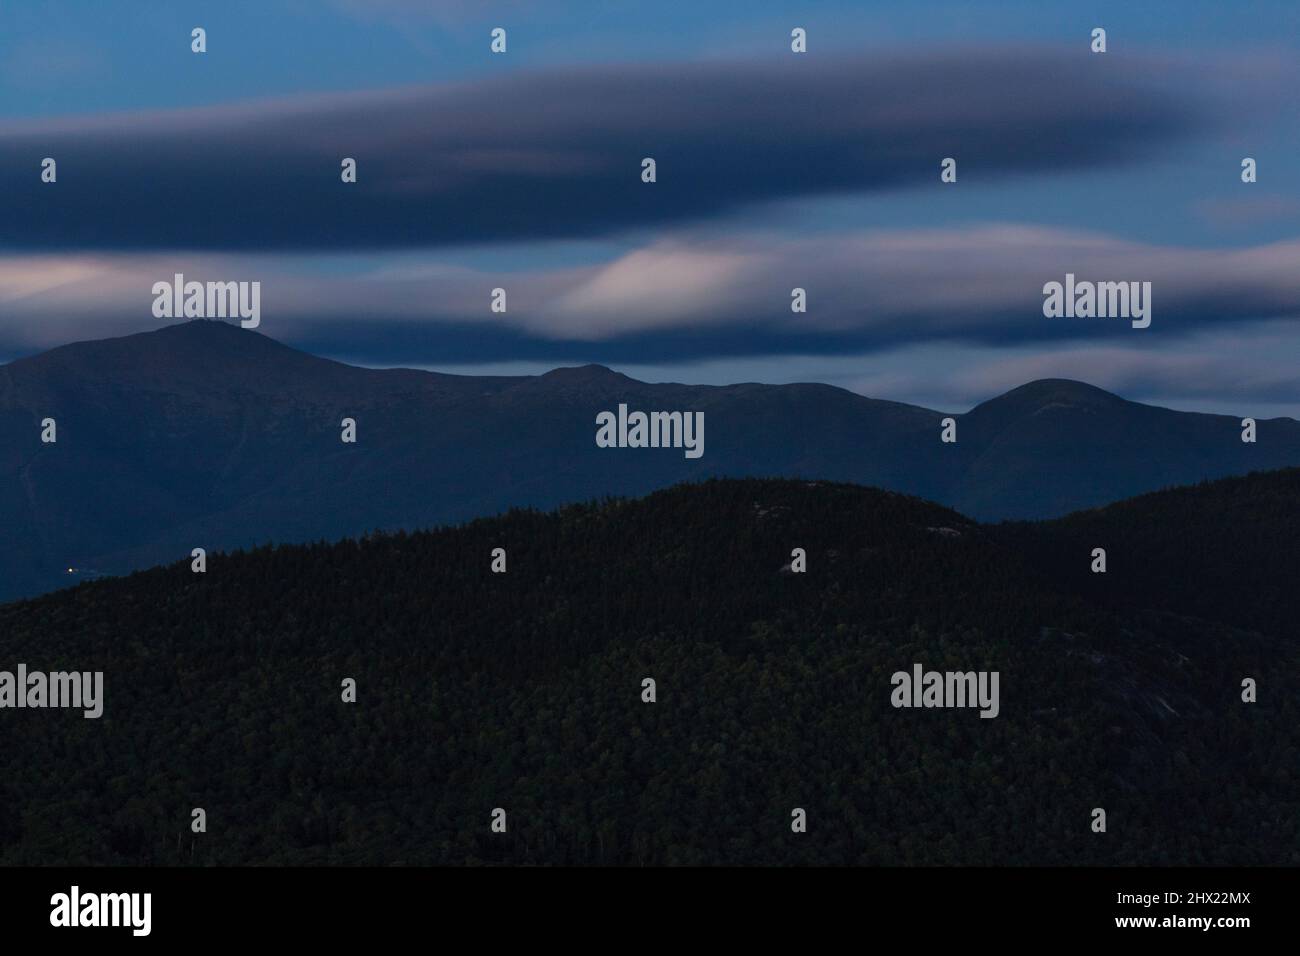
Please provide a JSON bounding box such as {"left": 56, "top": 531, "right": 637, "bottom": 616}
{"left": 0, "top": 473, "right": 1300, "bottom": 865}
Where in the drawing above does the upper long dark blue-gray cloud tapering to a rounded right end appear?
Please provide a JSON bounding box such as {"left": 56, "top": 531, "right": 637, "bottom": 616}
{"left": 0, "top": 49, "right": 1210, "bottom": 251}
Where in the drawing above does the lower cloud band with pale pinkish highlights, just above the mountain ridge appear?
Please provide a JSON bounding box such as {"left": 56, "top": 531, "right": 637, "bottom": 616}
{"left": 0, "top": 224, "right": 1300, "bottom": 363}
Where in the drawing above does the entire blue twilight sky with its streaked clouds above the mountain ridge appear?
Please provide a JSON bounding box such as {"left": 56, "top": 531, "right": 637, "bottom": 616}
{"left": 0, "top": 0, "right": 1300, "bottom": 418}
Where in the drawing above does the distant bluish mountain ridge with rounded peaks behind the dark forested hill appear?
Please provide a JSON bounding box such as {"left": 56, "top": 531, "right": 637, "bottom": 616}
{"left": 0, "top": 320, "right": 1300, "bottom": 598}
